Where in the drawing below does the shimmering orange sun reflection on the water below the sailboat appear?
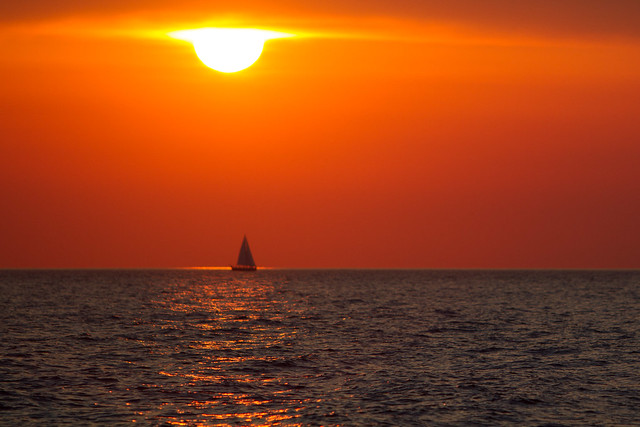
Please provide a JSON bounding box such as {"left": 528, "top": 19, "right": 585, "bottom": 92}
{"left": 132, "top": 271, "right": 304, "bottom": 425}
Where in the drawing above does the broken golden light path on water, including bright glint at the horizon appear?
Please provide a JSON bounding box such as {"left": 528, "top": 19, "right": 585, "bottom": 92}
{"left": 140, "top": 267, "right": 309, "bottom": 426}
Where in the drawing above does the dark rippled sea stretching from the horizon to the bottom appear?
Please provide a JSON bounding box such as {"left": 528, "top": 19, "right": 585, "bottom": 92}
{"left": 0, "top": 270, "right": 640, "bottom": 426}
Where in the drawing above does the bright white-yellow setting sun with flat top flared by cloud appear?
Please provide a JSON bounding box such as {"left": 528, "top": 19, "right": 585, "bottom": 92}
{"left": 169, "top": 28, "right": 293, "bottom": 73}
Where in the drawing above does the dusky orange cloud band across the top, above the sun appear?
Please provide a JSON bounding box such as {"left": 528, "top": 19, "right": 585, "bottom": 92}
{"left": 0, "top": 0, "right": 640, "bottom": 41}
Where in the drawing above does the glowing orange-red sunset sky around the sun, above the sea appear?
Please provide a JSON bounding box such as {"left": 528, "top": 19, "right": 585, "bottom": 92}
{"left": 0, "top": 0, "right": 640, "bottom": 268}
